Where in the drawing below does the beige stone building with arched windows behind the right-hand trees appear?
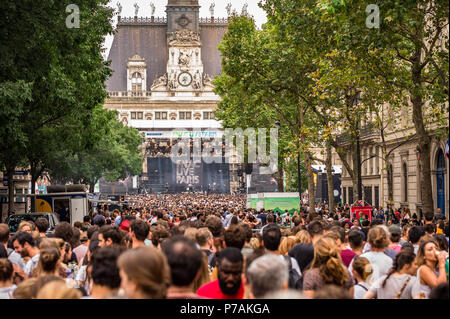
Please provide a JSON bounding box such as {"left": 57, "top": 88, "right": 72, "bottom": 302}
{"left": 336, "top": 108, "right": 450, "bottom": 217}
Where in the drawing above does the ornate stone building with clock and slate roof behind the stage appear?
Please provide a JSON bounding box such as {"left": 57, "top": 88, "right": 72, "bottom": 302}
{"left": 104, "top": 0, "right": 242, "bottom": 193}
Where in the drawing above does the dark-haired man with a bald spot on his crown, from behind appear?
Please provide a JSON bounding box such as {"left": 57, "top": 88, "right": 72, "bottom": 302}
{"left": 161, "top": 235, "right": 203, "bottom": 299}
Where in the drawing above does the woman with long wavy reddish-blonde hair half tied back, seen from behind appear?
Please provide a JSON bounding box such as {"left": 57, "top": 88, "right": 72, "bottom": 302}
{"left": 303, "top": 237, "right": 353, "bottom": 298}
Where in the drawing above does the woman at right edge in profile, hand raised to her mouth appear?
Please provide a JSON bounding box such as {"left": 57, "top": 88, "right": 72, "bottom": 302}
{"left": 417, "top": 237, "right": 447, "bottom": 299}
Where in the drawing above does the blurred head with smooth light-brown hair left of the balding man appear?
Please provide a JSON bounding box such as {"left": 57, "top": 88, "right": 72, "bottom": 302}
{"left": 117, "top": 247, "right": 170, "bottom": 299}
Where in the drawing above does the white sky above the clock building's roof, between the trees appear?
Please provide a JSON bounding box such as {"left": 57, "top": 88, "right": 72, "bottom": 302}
{"left": 103, "top": 0, "right": 267, "bottom": 58}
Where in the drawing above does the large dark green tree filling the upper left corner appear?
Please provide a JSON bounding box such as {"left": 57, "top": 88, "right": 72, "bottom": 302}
{"left": 0, "top": 0, "right": 113, "bottom": 212}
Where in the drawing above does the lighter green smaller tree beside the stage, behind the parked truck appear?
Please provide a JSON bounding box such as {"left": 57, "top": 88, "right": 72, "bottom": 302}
{"left": 47, "top": 108, "right": 143, "bottom": 191}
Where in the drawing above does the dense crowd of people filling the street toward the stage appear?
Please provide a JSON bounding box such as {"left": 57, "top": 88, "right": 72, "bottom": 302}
{"left": 0, "top": 194, "right": 449, "bottom": 299}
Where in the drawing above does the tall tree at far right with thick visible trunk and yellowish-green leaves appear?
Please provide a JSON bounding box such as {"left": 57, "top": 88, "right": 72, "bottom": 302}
{"left": 320, "top": 0, "right": 449, "bottom": 215}
